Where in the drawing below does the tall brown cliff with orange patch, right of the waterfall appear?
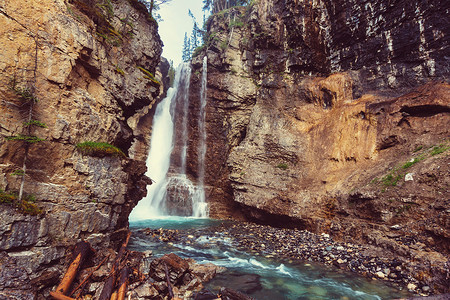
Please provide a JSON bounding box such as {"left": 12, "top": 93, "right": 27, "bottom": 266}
{"left": 189, "top": 0, "right": 450, "bottom": 290}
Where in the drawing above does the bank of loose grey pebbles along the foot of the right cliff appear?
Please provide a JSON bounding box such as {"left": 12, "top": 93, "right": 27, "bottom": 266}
{"left": 136, "top": 222, "right": 446, "bottom": 296}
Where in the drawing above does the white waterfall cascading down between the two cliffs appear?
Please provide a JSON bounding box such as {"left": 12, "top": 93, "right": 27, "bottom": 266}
{"left": 130, "top": 57, "right": 208, "bottom": 221}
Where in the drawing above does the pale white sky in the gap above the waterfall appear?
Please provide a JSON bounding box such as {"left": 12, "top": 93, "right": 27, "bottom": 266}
{"left": 158, "top": 0, "right": 203, "bottom": 67}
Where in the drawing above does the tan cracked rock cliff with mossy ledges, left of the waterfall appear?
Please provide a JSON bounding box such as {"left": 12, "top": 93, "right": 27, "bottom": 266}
{"left": 0, "top": 0, "right": 162, "bottom": 299}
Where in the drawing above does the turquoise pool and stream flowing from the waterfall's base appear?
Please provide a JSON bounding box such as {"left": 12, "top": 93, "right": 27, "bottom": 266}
{"left": 129, "top": 217, "right": 408, "bottom": 300}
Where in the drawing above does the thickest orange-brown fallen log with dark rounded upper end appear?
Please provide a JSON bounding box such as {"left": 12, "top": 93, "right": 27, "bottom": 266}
{"left": 53, "top": 241, "right": 93, "bottom": 299}
